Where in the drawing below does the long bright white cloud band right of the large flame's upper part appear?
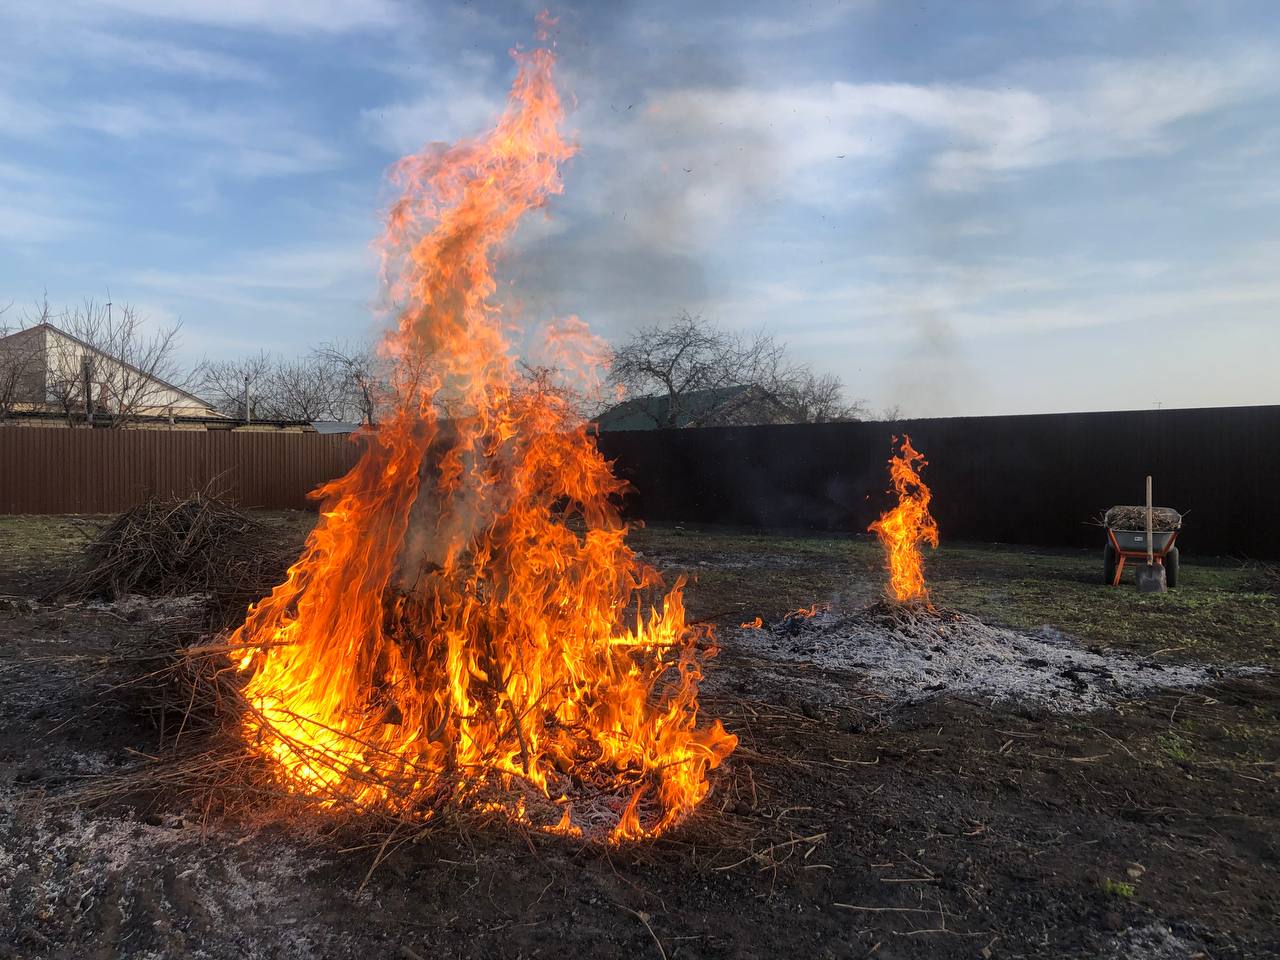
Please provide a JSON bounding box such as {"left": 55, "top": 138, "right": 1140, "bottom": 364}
{"left": 616, "top": 54, "right": 1276, "bottom": 207}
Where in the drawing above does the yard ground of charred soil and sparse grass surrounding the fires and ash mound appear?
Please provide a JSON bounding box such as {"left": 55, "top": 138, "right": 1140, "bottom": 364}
{"left": 0, "top": 516, "right": 1280, "bottom": 960}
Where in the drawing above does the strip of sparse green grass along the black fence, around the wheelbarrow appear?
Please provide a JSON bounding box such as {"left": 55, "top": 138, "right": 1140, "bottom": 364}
{"left": 631, "top": 525, "right": 1280, "bottom": 663}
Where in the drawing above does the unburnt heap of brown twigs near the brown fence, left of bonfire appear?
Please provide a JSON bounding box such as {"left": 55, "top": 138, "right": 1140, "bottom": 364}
{"left": 56, "top": 492, "right": 296, "bottom": 613}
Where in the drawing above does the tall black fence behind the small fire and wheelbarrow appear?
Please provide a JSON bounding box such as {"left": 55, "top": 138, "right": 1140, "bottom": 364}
{"left": 599, "top": 406, "right": 1280, "bottom": 558}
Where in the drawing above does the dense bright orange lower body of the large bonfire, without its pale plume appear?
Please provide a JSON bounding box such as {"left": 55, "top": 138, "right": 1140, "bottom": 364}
{"left": 232, "top": 398, "right": 736, "bottom": 841}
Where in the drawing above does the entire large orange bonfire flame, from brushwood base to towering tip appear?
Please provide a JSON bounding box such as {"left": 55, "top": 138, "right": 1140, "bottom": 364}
{"left": 230, "top": 26, "right": 737, "bottom": 841}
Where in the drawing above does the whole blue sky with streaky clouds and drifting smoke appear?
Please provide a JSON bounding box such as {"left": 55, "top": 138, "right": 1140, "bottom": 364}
{"left": 0, "top": 0, "right": 1280, "bottom": 416}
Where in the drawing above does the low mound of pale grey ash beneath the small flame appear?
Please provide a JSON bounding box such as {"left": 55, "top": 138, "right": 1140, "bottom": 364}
{"left": 735, "top": 600, "right": 1221, "bottom": 713}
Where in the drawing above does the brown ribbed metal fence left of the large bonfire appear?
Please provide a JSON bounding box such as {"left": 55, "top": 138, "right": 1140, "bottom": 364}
{"left": 0, "top": 426, "right": 360, "bottom": 513}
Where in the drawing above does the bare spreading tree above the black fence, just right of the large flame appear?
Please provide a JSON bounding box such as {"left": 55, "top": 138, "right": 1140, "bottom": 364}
{"left": 609, "top": 312, "right": 864, "bottom": 428}
